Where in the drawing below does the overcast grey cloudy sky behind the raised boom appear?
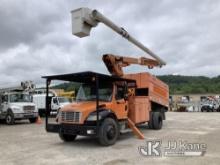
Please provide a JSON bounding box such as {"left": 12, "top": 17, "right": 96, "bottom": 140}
{"left": 0, "top": 0, "right": 220, "bottom": 85}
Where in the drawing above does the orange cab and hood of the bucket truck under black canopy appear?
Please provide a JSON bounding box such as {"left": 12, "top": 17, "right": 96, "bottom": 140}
{"left": 58, "top": 82, "right": 128, "bottom": 124}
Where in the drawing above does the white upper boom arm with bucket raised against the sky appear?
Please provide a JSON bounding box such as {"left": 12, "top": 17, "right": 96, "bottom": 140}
{"left": 71, "top": 8, "right": 166, "bottom": 67}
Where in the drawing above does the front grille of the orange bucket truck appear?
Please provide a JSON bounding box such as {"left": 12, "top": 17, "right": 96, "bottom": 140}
{"left": 61, "top": 112, "right": 81, "bottom": 123}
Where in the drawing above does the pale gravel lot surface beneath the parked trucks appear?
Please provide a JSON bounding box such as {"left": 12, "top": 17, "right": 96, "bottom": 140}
{"left": 0, "top": 112, "right": 220, "bottom": 165}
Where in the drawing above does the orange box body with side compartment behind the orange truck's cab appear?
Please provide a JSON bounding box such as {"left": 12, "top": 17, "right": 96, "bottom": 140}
{"left": 124, "top": 73, "right": 169, "bottom": 124}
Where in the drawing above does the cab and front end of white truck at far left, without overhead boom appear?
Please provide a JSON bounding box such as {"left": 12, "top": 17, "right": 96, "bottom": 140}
{"left": 0, "top": 92, "right": 38, "bottom": 125}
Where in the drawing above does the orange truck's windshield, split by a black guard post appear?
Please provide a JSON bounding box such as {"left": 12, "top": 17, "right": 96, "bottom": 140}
{"left": 76, "top": 84, "right": 112, "bottom": 101}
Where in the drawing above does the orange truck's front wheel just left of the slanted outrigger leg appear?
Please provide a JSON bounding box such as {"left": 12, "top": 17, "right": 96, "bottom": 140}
{"left": 98, "top": 118, "right": 119, "bottom": 146}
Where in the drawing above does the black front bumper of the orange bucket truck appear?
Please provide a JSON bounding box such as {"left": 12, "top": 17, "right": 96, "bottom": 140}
{"left": 46, "top": 124, "right": 97, "bottom": 136}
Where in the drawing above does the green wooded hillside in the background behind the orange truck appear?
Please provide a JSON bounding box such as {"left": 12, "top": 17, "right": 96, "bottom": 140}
{"left": 53, "top": 75, "right": 220, "bottom": 94}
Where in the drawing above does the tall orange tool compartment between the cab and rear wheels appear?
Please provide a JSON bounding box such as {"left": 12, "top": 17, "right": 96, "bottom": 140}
{"left": 128, "top": 96, "right": 150, "bottom": 124}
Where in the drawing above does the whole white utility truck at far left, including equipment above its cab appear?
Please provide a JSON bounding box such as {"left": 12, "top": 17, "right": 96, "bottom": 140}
{"left": 0, "top": 81, "right": 38, "bottom": 125}
